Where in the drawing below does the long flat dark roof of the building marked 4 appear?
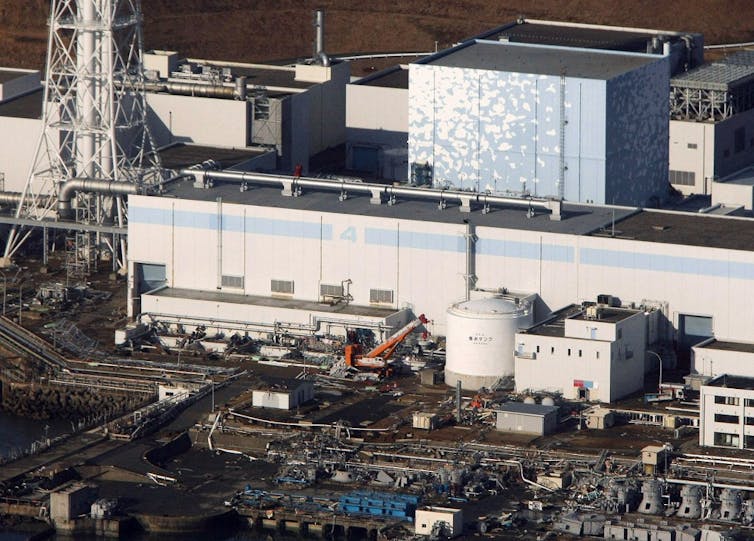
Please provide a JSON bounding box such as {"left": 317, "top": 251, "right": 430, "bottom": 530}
{"left": 151, "top": 179, "right": 754, "bottom": 251}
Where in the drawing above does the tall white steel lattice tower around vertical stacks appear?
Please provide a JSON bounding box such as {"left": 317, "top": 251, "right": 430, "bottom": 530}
{"left": 5, "top": 0, "right": 161, "bottom": 265}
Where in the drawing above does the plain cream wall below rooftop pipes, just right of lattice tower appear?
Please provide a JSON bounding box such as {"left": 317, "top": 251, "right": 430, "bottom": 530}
{"left": 147, "top": 93, "right": 249, "bottom": 148}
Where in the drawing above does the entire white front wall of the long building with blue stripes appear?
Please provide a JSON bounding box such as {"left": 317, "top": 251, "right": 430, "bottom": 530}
{"left": 129, "top": 196, "right": 754, "bottom": 340}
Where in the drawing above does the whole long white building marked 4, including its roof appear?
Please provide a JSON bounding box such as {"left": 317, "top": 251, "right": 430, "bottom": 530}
{"left": 129, "top": 172, "right": 754, "bottom": 380}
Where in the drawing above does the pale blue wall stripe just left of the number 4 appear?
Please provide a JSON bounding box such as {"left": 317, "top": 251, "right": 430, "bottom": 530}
{"left": 128, "top": 206, "right": 332, "bottom": 240}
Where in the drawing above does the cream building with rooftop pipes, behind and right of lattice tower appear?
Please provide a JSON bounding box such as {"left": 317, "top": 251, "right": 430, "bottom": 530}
{"left": 144, "top": 51, "right": 350, "bottom": 173}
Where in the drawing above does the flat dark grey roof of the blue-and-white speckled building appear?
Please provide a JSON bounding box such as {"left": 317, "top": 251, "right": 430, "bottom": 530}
{"left": 424, "top": 40, "right": 658, "bottom": 80}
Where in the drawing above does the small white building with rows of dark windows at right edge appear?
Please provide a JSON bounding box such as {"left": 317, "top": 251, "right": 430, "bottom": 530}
{"left": 699, "top": 374, "right": 754, "bottom": 449}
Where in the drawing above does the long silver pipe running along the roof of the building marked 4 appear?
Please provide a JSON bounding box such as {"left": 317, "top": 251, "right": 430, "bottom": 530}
{"left": 184, "top": 169, "right": 562, "bottom": 217}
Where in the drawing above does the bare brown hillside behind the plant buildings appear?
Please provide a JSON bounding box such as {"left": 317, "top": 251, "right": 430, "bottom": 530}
{"left": 0, "top": 0, "right": 754, "bottom": 68}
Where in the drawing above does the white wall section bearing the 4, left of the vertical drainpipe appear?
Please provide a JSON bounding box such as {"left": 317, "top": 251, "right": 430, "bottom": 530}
{"left": 129, "top": 196, "right": 466, "bottom": 334}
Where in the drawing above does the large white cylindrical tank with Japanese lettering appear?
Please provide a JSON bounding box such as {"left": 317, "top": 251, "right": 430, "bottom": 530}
{"left": 445, "top": 297, "right": 533, "bottom": 390}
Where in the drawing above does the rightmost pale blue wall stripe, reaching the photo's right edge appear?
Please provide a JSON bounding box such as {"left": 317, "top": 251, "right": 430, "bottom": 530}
{"left": 579, "top": 248, "right": 754, "bottom": 280}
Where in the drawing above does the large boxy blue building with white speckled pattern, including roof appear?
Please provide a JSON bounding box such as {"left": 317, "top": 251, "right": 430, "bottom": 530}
{"left": 409, "top": 40, "right": 669, "bottom": 205}
